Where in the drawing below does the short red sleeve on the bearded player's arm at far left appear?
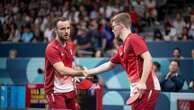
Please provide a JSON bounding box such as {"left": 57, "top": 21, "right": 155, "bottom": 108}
{"left": 46, "top": 47, "right": 62, "bottom": 65}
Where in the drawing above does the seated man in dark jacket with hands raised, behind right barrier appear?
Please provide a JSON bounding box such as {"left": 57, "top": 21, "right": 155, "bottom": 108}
{"left": 160, "top": 60, "right": 184, "bottom": 92}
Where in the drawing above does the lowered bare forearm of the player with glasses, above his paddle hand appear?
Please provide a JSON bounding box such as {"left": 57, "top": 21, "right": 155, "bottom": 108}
{"left": 141, "top": 57, "right": 152, "bottom": 83}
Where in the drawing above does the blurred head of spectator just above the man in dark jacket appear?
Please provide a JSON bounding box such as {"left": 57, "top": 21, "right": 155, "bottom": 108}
{"left": 172, "top": 47, "right": 184, "bottom": 60}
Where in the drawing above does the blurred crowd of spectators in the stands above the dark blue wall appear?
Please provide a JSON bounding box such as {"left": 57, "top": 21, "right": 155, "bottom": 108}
{"left": 0, "top": 0, "right": 194, "bottom": 43}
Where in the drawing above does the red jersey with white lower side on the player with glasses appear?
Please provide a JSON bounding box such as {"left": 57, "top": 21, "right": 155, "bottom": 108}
{"left": 111, "top": 33, "right": 160, "bottom": 89}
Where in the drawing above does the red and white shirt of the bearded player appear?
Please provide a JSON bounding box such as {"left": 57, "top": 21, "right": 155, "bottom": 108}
{"left": 44, "top": 39, "right": 73, "bottom": 94}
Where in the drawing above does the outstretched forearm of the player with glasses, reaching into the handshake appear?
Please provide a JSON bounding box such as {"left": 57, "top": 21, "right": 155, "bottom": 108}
{"left": 87, "top": 62, "right": 114, "bottom": 75}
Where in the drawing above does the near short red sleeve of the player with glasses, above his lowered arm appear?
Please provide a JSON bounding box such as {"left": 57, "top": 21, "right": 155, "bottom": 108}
{"left": 130, "top": 37, "right": 148, "bottom": 56}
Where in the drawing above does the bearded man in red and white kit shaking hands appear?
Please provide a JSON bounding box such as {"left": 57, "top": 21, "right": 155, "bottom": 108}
{"left": 44, "top": 17, "right": 87, "bottom": 110}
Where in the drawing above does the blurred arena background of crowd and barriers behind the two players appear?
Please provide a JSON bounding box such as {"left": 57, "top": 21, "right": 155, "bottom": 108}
{"left": 0, "top": 0, "right": 194, "bottom": 110}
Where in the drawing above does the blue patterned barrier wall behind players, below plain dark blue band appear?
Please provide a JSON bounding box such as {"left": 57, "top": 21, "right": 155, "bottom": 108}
{"left": 0, "top": 58, "right": 194, "bottom": 86}
